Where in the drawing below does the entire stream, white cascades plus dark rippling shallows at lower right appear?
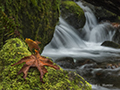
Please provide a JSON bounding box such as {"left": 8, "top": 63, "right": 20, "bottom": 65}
{"left": 42, "top": 2, "right": 120, "bottom": 90}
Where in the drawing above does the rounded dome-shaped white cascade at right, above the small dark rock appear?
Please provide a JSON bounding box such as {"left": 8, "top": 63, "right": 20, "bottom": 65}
{"left": 89, "top": 23, "right": 115, "bottom": 43}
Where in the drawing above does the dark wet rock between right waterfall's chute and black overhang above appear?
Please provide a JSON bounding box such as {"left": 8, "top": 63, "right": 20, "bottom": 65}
{"left": 80, "top": 0, "right": 120, "bottom": 22}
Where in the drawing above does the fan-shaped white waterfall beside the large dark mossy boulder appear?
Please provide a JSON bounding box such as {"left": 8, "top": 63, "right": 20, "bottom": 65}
{"left": 49, "top": 17, "right": 85, "bottom": 49}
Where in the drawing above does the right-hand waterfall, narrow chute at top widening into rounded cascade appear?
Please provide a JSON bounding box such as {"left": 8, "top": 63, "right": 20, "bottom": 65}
{"left": 77, "top": 2, "right": 114, "bottom": 42}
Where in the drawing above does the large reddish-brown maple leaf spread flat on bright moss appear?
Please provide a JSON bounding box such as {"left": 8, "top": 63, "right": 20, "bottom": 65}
{"left": 11, "top": 50, "right": 60, "bottom": 83}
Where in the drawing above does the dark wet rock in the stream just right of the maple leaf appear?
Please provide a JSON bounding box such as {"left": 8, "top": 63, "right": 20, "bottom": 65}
{"left": 55, "top": 57, "right": 75, "bottom": 69}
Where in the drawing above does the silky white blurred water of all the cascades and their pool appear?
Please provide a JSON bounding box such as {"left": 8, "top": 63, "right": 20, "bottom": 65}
{"left": 42, "top": 2, "right": 120, "bottom": 90}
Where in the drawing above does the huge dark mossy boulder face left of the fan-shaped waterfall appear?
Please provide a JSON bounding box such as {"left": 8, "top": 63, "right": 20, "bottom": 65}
{"left": 0, "top": 0, "right": 60, "bottom": 50}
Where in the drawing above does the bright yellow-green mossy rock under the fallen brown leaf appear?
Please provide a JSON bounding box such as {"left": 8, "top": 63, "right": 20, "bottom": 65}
{"left": 0, "top": 38, "right": 92, "bottom": 90}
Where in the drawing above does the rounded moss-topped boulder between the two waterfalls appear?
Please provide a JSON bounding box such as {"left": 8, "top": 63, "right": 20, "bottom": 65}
{"left": 61, "top": 1, "right": 86, "bottom": 29}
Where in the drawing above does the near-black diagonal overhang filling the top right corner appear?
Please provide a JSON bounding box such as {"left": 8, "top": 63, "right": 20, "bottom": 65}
{"left": 84, "top": 0, "right": 120, "bottom": 16}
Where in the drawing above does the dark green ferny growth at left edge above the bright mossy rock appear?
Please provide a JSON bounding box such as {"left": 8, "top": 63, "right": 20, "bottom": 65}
{"left": 0, "top": 7, "right": 22, "bottom": 49}
